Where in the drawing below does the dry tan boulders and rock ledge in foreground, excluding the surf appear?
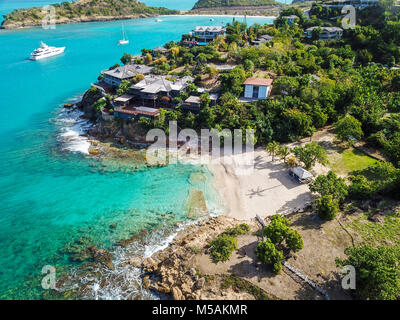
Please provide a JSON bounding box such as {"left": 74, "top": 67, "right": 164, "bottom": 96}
{"left": 127, "top": 216, "right": 272, "bottom": 300}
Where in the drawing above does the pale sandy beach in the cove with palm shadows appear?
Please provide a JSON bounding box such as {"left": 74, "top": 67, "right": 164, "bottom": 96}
{"left": 209, "top": 150, "right": 312, "bottom": 220}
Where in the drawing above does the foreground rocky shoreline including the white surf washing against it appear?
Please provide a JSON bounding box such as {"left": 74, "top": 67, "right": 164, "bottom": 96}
{"left": 48, "top": 216, "right": 277, "bottom": 300}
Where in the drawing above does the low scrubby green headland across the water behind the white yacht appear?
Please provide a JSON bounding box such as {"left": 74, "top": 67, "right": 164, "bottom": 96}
{"left": 2, "top": 0, "right": 178, "bottom": 26}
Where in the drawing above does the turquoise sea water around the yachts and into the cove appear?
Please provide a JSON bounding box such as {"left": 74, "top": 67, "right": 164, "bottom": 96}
{"left": 0, "top": 13, "right": 270, "bottom": 299}
